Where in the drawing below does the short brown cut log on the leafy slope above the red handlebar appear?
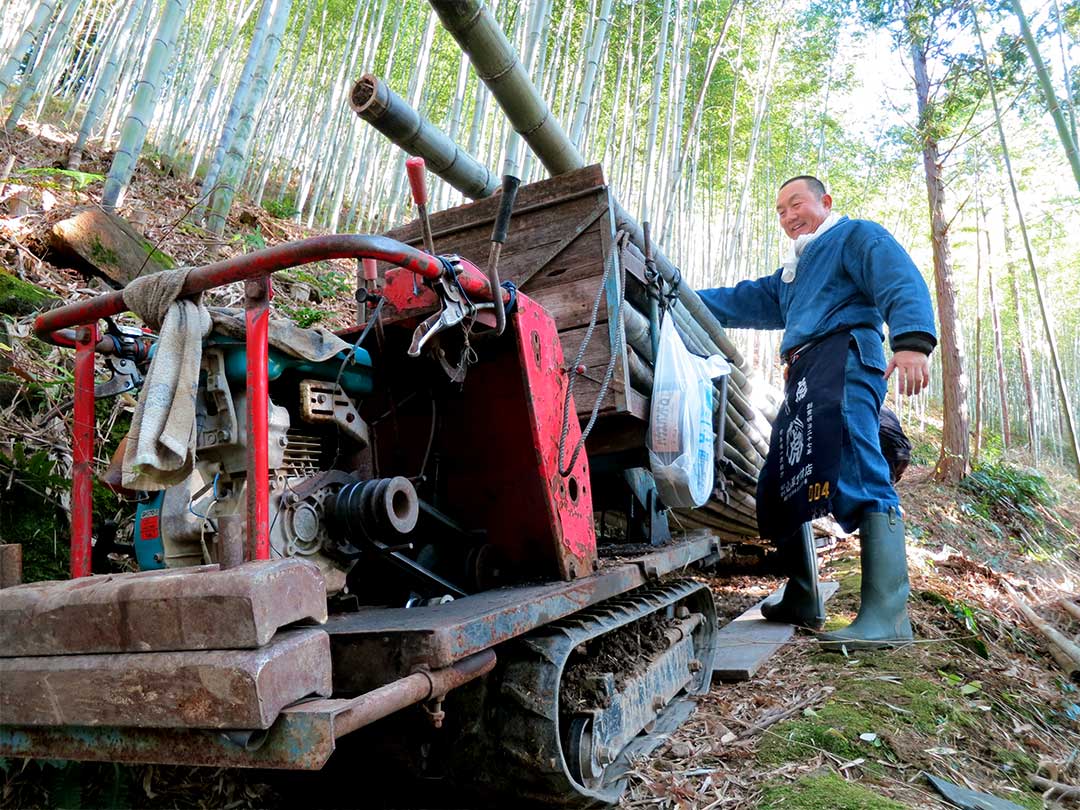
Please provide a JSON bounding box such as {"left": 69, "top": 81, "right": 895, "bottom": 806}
{"left": 51, "top": 207, "right": 176, "bottom": 287}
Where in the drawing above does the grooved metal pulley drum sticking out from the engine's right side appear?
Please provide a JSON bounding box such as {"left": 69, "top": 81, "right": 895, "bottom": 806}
{"left": 326, "top": 475, "right": 420, "bottom": 540}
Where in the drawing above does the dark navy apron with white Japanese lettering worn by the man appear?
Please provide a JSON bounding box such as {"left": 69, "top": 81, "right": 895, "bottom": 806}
{"left": 757, "top": 332, "right": 851, "bottom": 542}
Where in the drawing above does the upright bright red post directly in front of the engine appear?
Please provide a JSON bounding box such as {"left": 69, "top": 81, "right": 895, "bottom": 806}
{"left": 244, "top": 275, "right": 271, "bottom": 559}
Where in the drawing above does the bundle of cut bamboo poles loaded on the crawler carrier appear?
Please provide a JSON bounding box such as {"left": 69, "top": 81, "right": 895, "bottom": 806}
{"left": 351, "top": 0, "right": 774, "bottom": 546}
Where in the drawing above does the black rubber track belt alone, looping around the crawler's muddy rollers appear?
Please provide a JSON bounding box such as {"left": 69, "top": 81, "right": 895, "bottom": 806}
{"left": 482, "top": 580, "right": 716, "bottom": 807}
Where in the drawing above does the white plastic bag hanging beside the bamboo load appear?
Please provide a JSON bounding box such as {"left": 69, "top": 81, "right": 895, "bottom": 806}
{"left": 646, "top": 315, "right": 731, "bottom": 507}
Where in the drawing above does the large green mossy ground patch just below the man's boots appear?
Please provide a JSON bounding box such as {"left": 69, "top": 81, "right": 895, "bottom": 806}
{"left": 757, "top": 652, "right": 975, "bottom": 771}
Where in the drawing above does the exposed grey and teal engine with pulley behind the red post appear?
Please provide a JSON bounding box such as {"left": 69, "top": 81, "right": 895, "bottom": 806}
{"left": 135, "top": 335, "right": 419, "bottom": 594}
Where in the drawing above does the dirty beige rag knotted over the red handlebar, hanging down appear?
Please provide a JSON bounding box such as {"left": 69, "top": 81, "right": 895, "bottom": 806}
{"left": 121, "top": 268, "right": 211, "bottom": 491}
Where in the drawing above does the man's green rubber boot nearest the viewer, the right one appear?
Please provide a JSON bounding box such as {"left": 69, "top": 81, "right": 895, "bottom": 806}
{"left": 818, "top": 511, "right": 914, "bottom": 650}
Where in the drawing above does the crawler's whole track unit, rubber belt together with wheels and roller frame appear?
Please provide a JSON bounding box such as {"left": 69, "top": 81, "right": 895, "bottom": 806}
{"left": 453, "top": 580, "right": 717, "bottom": 807}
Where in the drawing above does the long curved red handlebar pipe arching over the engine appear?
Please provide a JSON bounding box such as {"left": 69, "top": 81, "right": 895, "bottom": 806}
{"left": 33, "top": 233, "right": 510, "bottom": 346}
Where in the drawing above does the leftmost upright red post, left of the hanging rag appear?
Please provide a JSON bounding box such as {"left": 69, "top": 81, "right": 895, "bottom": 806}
{"left": 71, "top": 324, "right": 97, "bottom": 579}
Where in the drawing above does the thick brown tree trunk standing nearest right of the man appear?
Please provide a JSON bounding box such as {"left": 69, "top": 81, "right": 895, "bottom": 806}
{"left": 912, "top": 36, "right": 970, "bottom": 482}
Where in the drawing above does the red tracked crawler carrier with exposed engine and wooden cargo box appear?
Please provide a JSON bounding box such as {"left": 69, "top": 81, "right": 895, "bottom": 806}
{"left": 0, "top": 162, "right": 777, "bottom": 805}
